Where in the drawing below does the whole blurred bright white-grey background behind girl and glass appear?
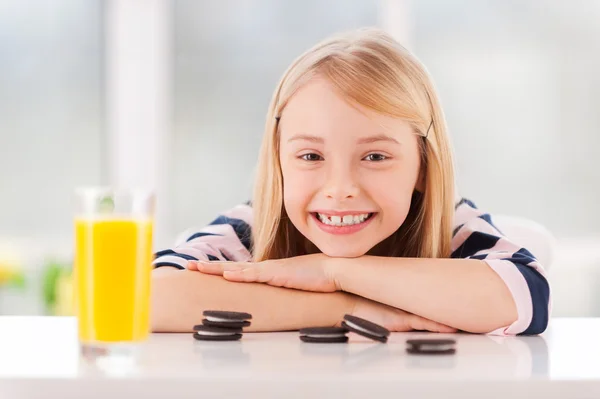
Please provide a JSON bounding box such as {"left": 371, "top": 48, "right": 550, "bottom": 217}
{"left": 0, "top": 0, "right": 600, "bottom": 316}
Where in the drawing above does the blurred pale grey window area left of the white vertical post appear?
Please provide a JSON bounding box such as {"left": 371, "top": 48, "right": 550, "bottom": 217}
{"left": 0, "top": 0, "right": 105, "bottom": 247}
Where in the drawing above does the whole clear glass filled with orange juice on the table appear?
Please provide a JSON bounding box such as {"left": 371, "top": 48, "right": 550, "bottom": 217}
{"left": 73, "top": 188, "right": 155, "bottom": 355}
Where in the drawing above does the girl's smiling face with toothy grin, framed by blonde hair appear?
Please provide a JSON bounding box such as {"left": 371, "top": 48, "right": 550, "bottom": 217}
{"left": 279, "top": 78, "right": 422, "bottom": 257}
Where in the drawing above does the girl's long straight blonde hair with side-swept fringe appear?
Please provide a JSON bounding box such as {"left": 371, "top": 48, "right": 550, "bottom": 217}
{"left": 252, "top": 29, "right": 454, "bottom": 261}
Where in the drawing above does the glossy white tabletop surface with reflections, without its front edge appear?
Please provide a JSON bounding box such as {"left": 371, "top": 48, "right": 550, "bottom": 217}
{"left": 0, "top": 317, "right": 600, "bottom": 381}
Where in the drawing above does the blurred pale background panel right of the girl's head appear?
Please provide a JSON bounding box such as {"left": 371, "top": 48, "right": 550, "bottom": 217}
{"left": 412, "top": 0, "right": 600, "bottom": 237}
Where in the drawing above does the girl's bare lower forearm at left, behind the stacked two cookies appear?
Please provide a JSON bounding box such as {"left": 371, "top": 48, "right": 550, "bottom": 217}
{"left": 152, "top": 267, "right": 353, "bottom": 332}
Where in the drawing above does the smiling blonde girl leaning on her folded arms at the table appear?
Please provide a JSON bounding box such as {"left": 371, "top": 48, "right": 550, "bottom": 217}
{"left": 153, "top": 29, "right": 550, "bottom": 335}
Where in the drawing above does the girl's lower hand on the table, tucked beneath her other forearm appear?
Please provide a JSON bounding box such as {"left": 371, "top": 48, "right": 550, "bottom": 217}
{"left": 352, "top": 295, "right": 457, "bottom": 333}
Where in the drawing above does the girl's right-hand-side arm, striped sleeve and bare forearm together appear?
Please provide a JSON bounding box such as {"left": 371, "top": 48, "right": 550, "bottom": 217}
{"left": 334, "top": 200, "right": 550, "bottom": 335}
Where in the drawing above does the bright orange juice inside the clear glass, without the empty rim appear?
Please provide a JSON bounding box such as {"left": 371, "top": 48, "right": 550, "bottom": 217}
{"left": 74, "top": 218, "right": 152, "bottom": 343}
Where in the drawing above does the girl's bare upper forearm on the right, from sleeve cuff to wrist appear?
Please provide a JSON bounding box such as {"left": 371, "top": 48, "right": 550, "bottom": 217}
{"left": 335, "top": 256, "right": 517, "bottom": 333}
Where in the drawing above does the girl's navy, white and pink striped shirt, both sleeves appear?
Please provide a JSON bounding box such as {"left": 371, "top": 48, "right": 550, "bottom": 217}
{"left": 153, "top": 198, "right": 550, "bottom": 335}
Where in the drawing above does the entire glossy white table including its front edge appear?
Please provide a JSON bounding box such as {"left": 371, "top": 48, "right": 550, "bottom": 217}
{"left": 0, "top": 317, "right": 600, "bottom": 399}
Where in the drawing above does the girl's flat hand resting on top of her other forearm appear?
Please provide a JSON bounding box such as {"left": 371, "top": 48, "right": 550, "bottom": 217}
{"left": 188, "top": 254, "right": 339, "bottom": 292}
